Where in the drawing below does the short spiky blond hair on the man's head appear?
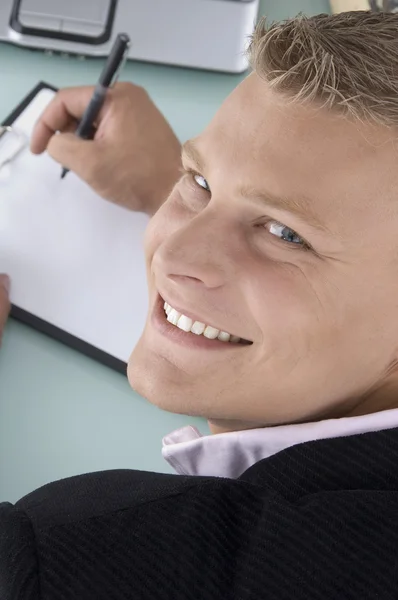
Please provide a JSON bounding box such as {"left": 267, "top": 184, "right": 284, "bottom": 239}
{"left": 249, "top": 11, "right": 398, "bottom": 126}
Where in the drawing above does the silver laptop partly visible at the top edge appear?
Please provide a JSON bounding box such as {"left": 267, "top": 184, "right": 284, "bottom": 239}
{"left": 0, "top": 0, "right": 259, "bottom": 73}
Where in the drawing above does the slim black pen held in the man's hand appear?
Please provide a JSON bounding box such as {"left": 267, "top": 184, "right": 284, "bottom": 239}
{"left": 61, "top": 33, "right": 130, "bottom": 179}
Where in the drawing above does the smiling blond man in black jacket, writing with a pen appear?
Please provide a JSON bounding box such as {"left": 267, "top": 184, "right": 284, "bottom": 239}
{"left": 0, "top": 12, "right": 398, "bottom": 600}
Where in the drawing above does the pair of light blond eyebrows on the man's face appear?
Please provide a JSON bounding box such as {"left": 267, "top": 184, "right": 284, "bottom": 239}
{"left": 182, "top": 140, "right": 329, "bottom": 232}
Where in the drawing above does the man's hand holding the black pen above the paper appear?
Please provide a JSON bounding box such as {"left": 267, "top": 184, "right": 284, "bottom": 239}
{"left": 31, "top": 83, "right": 181, "bottom": 215}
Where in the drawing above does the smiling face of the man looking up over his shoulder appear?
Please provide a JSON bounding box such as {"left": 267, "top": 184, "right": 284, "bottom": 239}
{"left": 129, "top": 74, "right": 398, "bottom": 429}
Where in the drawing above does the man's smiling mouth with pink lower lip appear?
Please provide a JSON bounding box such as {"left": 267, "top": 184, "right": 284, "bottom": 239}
{"left": 152, "top": 294, "right": 253, "bottom": 350}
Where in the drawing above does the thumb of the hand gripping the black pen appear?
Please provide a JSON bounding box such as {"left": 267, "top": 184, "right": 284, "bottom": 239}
{"left": 47, "top": 133, "right": 103, "bottom": 183}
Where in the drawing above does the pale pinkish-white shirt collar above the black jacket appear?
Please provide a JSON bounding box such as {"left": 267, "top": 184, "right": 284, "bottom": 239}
{"left": 162, "top": 408, "right": 398, "bottom": 479}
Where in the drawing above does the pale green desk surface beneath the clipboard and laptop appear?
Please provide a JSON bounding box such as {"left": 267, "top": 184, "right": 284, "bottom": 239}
{"left": 0, "top": 0, "right": 328, "bottom": 502}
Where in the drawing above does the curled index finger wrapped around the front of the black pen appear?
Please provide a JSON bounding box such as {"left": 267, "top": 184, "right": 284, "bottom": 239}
{"left": 30, "top": 85, "right": 94, "bottom": 154}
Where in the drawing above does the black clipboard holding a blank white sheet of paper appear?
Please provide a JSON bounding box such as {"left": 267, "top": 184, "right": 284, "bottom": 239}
{"left": 0, "top": 82, "right": 149, "bottom": 374}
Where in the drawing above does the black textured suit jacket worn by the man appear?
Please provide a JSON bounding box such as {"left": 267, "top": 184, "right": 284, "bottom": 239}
{"left": 0, "top": 429, "right": 398, "bottom": 600}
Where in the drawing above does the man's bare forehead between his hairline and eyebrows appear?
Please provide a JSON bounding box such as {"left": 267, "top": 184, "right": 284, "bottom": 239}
{"left": 197, "top": 73, "right": 398, "bottom": 232}
